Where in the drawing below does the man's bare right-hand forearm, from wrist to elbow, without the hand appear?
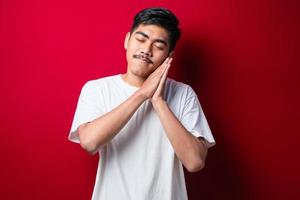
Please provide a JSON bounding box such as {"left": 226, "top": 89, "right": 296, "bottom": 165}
{"left": 153, "top": 100, "right": 207, "bottom": 172}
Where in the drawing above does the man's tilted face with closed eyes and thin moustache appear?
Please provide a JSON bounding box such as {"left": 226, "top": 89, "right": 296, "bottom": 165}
{"left": 125, "top": 24, "right": 170, "bottom": 78}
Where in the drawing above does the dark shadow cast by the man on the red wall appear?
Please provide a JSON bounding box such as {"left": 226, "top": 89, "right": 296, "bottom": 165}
{"left": 176, "top": 37, "right": 251, "bottom": 200}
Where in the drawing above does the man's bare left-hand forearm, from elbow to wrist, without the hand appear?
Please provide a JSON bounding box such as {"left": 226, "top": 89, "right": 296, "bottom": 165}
{"left": 78, "top": 91, "right": 146, "bottom": 153}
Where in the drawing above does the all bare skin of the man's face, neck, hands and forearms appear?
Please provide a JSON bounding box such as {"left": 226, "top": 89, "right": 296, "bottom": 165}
{"left": 78, "top": 25, "right": 207, "bottom": 172}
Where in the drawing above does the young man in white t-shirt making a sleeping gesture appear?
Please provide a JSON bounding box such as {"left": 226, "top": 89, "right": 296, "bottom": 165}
{"left": 69, "top": 8, "right": 215, "bottom": 200}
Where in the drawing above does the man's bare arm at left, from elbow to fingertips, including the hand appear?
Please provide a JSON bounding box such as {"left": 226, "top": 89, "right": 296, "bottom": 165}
{"left": 77, "top": 59, "right": 168, "bottom": 154}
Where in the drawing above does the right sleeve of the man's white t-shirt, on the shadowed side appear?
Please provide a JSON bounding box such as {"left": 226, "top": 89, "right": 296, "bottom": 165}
{"left": 181, "top": 87, "right": 216, "bottom": 147}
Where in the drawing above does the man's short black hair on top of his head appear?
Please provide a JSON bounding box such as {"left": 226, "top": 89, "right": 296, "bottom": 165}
{"left": 130, "top": 7, "right": 181, "bottom": 52}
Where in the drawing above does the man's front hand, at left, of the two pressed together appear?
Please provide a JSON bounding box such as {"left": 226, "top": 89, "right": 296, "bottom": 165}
{"left": 140, "top": 57, "right": 172, "bottom": 99}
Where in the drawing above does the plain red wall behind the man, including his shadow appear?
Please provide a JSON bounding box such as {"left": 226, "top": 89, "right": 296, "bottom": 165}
{"left": 0, "top": 0, "right": 300, "bottom": 200}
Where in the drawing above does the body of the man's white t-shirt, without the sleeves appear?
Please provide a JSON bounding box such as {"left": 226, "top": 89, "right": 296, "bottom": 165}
{"left": 92, "top": 75, "right": 187, "bottom": 200}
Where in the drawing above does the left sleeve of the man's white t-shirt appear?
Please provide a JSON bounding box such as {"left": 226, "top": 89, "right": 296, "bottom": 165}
{"left": 68, "top": 81, "right": 103, "bottom": 143}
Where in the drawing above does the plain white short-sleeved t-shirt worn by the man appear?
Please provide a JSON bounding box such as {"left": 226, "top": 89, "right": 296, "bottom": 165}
{"left": 69, "top": 74, "right": 215, "bottom": 200}
